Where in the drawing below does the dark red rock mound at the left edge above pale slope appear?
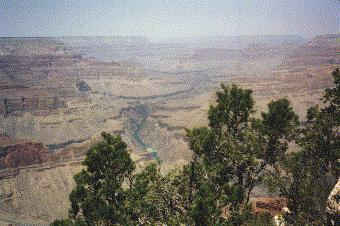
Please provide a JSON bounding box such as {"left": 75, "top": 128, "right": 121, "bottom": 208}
{"left": 0, "top": 142, "right": 49, "bottom": 169}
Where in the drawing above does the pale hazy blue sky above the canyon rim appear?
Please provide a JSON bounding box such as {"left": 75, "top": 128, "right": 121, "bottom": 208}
{"left": 0, "top": 0, "right": 340, "bottom": 38}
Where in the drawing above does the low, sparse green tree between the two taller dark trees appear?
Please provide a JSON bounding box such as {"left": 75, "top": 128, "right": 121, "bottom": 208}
{"left": 129, "top": 164, "right": 186, "bottom": 225}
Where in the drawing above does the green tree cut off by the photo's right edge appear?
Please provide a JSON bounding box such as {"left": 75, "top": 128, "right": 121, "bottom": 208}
{"left": 271, "top": 69, "right": 340, "bottom": 225}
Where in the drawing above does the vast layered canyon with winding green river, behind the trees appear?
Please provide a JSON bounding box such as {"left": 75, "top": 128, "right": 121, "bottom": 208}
{"left": 0, "top": 35, "right": 340, "bottom": 224}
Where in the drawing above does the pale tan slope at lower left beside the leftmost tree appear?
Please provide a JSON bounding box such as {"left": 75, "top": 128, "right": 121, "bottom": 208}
{"left": 0, "top": 160, "right": 82, "bottom": 224}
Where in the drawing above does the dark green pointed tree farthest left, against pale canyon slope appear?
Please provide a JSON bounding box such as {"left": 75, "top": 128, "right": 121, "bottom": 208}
{"left": 70, "top": 133, "right": 135, "bottom": 225}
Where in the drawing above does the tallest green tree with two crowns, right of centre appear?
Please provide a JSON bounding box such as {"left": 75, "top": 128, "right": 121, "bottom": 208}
{"left": 184, "top": 85, "right": 298, "bottom": 225}
